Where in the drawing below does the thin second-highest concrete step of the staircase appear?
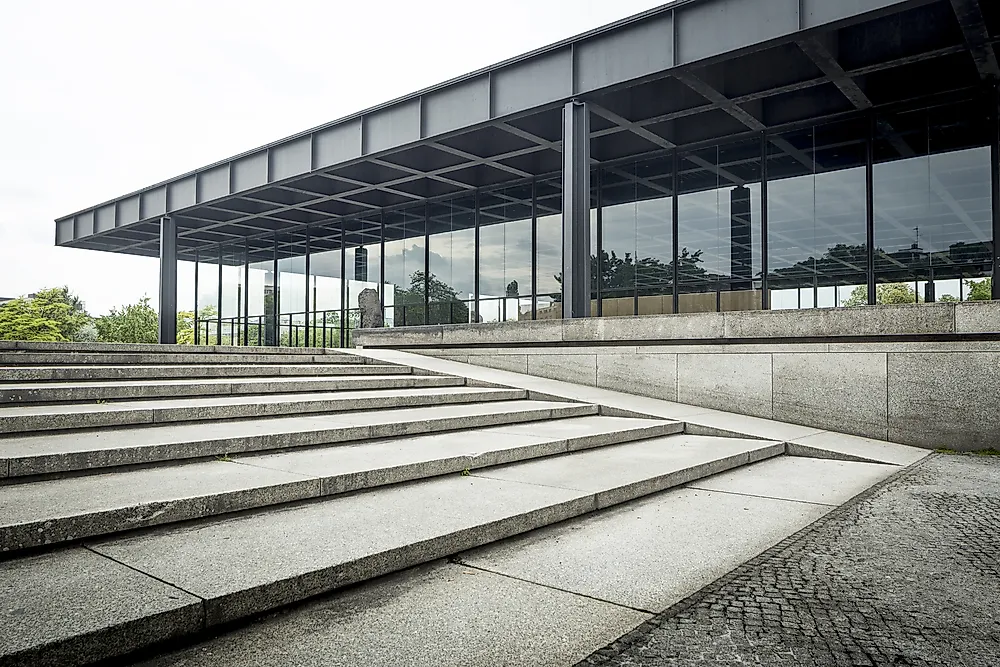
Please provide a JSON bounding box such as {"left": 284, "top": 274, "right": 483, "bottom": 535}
{"left": 0, "top": 347, "right": 359, "bottom": 366}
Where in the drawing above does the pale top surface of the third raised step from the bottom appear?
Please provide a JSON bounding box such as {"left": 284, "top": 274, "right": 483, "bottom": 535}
{"left": 0, "top": 399, "right": 581, "bottom": 459}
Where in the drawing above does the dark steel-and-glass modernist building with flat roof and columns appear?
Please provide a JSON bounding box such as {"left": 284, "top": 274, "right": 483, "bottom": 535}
{"left": 56, "top": 0, "right": 1000, "bottom": 345}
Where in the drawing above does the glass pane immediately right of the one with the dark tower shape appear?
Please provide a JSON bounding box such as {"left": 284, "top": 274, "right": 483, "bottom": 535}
{"left": 767, "top": 120, "right": 868, "bottom": 310}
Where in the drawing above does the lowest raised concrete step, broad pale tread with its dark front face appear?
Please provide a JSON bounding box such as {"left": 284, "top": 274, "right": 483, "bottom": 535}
{"left": 0, "top": 435, "right": 784, "bottom": 665}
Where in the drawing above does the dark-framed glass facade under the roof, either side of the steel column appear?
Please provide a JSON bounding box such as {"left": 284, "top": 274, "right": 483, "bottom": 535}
{"left": 195, "top": 91, "right": 996, "bottom": 347}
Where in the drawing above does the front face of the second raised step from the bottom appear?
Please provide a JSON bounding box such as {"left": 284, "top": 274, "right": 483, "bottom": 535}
{"left": 0, "top": 423, "right": 683, "bottom": 552}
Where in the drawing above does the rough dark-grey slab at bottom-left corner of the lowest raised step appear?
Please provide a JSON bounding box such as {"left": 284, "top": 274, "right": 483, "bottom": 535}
{"left": 0, "top": 548, "right": 202, "bottom": 667}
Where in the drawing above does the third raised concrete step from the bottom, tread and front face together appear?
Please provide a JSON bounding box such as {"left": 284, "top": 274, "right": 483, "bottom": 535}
{"left": 0, "top": 400, "right": 598, "bottom": 478}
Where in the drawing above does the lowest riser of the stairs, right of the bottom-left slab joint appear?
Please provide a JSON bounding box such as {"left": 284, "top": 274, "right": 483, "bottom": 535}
{"left": 204, "top": 445, "right": 784, "bottom": 627}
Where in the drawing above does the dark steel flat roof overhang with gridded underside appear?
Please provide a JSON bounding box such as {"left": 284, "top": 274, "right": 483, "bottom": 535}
{"left": 56, "top": 0, "right": 1000, "bottom": 259}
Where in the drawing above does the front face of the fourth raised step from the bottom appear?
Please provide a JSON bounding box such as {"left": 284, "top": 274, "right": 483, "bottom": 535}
{"left": 0, "top": 389, "right": 526, "bottom": 433}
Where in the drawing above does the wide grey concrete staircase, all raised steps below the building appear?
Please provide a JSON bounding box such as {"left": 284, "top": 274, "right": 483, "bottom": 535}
{"left": 0, "top": 344, "right": 784, "bottom": 665}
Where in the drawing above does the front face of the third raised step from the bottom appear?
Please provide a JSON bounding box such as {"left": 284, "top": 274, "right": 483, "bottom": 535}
{"left": 0, "top": 399, "right": 597, "bottom": 478}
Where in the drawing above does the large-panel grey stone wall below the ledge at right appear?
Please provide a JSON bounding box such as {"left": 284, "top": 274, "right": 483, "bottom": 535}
{"left": 376, "top": 342, "right": 1000, "bottom": 451}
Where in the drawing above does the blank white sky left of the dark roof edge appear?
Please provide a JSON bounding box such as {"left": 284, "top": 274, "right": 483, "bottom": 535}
{"left": 0, "top": 0, "right": 665, "bottom": 314}
